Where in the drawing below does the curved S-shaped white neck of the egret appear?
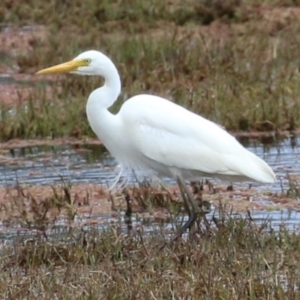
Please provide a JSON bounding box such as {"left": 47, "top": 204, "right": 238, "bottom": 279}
{"left": 86, "top": 62, "right": 121, "bottom": 152}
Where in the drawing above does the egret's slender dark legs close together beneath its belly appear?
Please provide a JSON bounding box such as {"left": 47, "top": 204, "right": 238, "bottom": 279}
{"left": 177, "top": 176, "right": 199, "bottom": 234}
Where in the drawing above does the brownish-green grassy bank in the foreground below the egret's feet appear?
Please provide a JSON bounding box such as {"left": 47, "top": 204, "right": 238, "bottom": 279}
{"left": 0, "top": 214, "right": 300, "bottom": 300}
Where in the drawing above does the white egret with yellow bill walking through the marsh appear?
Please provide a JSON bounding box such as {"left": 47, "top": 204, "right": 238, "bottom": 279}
{"left": 36, "top": 50, "right": 276, "bottom": 233}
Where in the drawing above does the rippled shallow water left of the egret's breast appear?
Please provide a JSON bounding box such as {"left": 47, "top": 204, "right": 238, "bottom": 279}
{"left": 0, "top": 145, "right": 116, "bottom": 186}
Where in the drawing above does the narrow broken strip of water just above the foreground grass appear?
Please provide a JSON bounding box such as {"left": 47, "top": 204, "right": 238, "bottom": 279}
{"left": 0, "top": 210, "right": 300, "bottom": 245}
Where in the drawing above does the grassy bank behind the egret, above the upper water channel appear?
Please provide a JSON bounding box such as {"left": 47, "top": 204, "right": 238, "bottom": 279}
{"left": 0, "top": 0, "right": 300, "bottom": 140}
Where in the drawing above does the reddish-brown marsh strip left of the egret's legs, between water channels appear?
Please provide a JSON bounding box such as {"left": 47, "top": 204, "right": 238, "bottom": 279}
{"left": 0, "top": 178, "right": 184, "bottom": 235}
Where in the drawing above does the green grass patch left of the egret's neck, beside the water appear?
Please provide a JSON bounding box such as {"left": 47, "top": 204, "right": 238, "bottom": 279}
{"left": 0, "top": 82, "right": 94, "bottom": 140}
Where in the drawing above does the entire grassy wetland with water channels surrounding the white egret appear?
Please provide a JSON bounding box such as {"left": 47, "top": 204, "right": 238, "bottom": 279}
{"left": 0, "top": 0, "right": 300, "bottom": 300}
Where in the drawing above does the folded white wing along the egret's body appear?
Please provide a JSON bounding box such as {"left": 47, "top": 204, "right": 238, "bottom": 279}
{"left": 121, "top": 95, "right": 272, "bottom": 181}
